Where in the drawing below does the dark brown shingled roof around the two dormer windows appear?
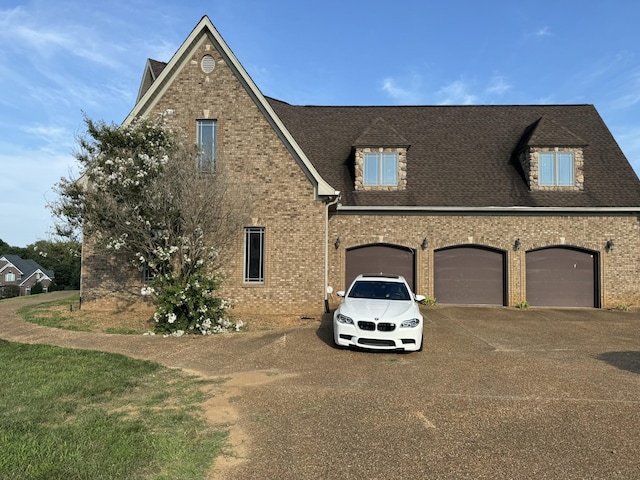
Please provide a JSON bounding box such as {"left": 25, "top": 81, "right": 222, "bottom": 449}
{"left": 267, "top": 98, "right": 640, "bottom": 208}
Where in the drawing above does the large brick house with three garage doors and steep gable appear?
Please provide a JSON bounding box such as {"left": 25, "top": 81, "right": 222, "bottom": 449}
{"left": 82, "top": 17, "right": 640, "bottom": 314}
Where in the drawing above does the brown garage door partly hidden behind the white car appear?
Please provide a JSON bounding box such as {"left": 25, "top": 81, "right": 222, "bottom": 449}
{"left": 345, "top": 244, "right": 415, "bottom": 291}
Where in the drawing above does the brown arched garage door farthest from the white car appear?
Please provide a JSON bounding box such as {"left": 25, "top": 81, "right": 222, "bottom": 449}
{"left": 527, "top": 247, "right": 598, "bottom": 307}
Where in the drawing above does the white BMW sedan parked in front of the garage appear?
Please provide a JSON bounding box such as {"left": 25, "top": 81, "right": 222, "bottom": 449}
{"left": 333, "top": 274, "right": 425, "bottom": 352}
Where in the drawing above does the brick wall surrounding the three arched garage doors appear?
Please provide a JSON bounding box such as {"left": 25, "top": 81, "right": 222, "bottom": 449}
{"left": 329, "top": 214, "right": 640, "bottom": 307}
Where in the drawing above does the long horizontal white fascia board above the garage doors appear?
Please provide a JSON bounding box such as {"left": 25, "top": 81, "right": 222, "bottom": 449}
{"left": 337, "top": 205, "right": 640, "bottom": 215}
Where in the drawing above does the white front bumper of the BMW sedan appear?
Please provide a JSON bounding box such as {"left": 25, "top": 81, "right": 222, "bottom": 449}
{"left": 333, "top": 320, "right": 422, "bottom": 352}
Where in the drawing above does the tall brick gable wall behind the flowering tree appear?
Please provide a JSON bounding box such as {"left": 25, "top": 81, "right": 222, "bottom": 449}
{"left": 82, "top": 34, "right": 325, "bottom": 315}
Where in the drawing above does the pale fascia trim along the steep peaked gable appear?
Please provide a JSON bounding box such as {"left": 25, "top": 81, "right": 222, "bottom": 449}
{"left": 123, "top": 16, "right": 336, "bottom": 196}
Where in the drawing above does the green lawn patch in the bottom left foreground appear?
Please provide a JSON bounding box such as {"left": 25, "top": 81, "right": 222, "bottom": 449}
{"left": 0, "top": 340, "right": 227, "bottom": 480}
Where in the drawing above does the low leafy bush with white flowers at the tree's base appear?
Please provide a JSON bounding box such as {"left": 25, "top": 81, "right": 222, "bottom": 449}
{"left": 141, "top": 274, "right": 243, "bottom": 336}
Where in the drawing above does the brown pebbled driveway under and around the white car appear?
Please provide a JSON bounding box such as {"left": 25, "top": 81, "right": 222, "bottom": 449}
{"left": 0, "top": 290, "right": 640, "bottom": 480}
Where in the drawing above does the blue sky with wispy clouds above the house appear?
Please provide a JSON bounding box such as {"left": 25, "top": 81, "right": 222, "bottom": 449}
{"left": 0, "top": 0, "right": 640, "bottom": 248}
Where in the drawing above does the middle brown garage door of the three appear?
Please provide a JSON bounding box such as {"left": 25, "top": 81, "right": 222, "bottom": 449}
{"left": 433, "top": 246, "right": 506, "bottom": 305}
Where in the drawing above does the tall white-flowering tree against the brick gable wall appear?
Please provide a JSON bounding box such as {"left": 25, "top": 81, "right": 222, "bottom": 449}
{"left": 50, "top": 118, "right": 251, "bottom": 333}
